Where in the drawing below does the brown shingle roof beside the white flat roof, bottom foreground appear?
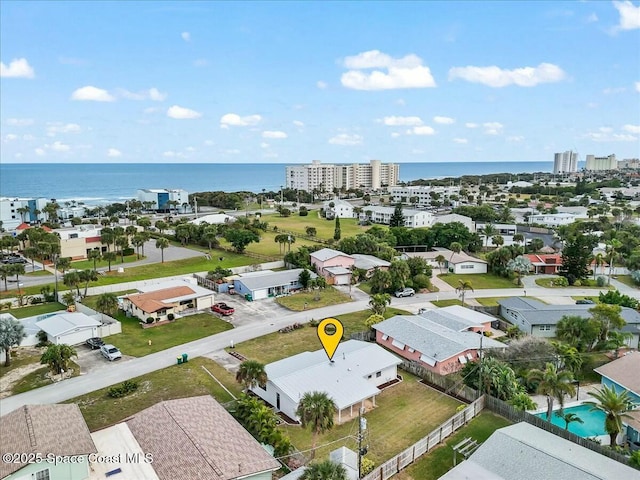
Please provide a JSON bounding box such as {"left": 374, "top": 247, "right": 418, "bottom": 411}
{"left": 127, "top": 395, "right": 280, "bottom": 480}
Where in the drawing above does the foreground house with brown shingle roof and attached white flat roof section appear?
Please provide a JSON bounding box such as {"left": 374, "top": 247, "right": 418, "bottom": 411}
{"left": 92, "top": 395, "right": 280, "bottom": 480}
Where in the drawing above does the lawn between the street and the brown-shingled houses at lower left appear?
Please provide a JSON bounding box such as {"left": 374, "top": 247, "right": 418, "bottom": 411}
{"left": 65, "top": 357, "right": 241, "bottom": 431}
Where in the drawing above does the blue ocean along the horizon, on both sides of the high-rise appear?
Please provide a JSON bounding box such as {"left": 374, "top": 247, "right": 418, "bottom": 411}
{"left": 0, "top": 162, "right": 553, "bottom": 204}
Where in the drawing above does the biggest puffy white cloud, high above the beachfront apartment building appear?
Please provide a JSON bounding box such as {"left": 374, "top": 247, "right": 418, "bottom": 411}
{"left": 340, "top": 50, "right": 436, "bottom": 90}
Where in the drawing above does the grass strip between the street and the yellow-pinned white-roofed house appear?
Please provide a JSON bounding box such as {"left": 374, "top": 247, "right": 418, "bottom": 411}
{"left": 227, "top": 308, "right": 408, "bottom": 364}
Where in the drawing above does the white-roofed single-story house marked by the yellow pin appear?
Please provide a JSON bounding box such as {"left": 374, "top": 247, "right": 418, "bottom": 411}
{"left": 251, "top": 340, "right": 402, "bottom": 423}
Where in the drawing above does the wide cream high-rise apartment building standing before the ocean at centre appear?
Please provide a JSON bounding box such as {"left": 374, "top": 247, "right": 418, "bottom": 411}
{"left": 285, "top": 160, "right": 400, "bottom": 192}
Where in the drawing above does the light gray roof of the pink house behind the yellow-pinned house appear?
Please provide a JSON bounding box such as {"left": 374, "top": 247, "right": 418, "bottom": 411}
{"left": 373, "top": 315, "right": 506, "bottom": 362}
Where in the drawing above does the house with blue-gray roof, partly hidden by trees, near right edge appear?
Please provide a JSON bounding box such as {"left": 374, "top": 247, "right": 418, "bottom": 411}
{"left": 498, "top": 297, "right": 640, "bottom": 348}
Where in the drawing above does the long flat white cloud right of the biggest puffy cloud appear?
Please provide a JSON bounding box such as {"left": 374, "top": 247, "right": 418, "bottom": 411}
{"left": 449, "top": 63, "right": 566, "bottom": 88}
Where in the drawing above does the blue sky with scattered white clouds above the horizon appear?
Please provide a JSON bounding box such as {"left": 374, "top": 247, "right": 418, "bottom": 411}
{"left": 0, "top": 0, "right": 640, "bottom": 163}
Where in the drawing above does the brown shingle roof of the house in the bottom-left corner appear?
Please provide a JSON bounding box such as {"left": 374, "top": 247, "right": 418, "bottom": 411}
{"left": 0, "top": 404, "right": 97, "bottom": 478}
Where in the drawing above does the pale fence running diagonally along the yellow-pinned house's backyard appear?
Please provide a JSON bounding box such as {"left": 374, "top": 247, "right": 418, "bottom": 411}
{"left": 362, "top": 397, "right": 484, "bottom": 480}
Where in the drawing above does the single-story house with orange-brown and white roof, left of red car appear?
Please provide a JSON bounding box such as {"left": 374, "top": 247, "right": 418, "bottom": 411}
{"left": 122, "top": 280, "right": 213, "bottom": 322}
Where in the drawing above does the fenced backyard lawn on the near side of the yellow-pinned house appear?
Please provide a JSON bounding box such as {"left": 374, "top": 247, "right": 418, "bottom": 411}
{"left": 281, "top": 371, "right": 461, "bottom": 466}
